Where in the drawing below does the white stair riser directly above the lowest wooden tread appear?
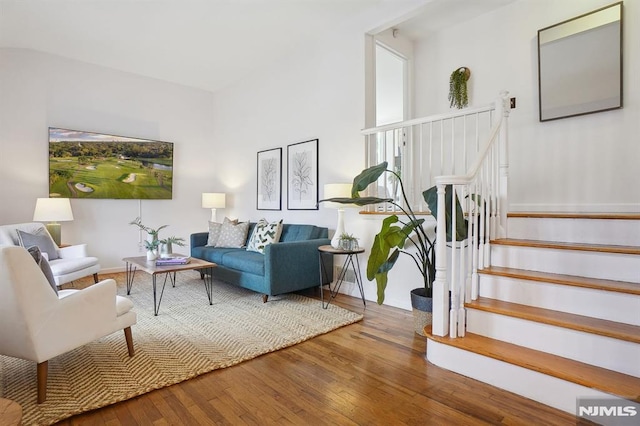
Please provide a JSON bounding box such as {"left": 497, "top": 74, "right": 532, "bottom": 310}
{"left": 467, "top": 309, "right": 640, "bottom": 377}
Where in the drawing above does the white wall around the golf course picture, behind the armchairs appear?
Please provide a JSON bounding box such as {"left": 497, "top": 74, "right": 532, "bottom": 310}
{"left": 0, "top": 49, "right": 219, "bottom": 270}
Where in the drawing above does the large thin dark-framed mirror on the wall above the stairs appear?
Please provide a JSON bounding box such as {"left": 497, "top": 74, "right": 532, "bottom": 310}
{"left": 538, "top": 2, "right": 622, "bottom": 121}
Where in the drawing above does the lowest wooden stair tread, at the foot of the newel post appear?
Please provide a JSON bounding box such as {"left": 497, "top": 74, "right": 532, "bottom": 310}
{"left": 425, "top": 328, "right": 640, "bottom": 402}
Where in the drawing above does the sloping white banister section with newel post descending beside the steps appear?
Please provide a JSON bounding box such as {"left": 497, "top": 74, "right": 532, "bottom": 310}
{"left": 432, "top": 92, "right": 510, "bottom": 337}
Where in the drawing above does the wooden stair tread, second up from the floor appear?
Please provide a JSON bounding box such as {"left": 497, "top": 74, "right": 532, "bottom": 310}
{"left": 465, "top": 297, "right": 640, "bottom": 344}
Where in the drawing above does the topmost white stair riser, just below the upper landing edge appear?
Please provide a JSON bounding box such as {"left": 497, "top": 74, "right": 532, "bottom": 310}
{"left": 508, "top": 218, "right": 640, "bottom": 246}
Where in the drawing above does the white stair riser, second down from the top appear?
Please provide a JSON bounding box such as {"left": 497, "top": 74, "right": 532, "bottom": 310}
{"left": 491, "top": 244, "right": 640, "bottom": 283}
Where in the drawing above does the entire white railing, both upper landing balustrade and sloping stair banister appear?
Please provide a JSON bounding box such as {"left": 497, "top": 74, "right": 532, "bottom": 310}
{"left": 362, "top": 92, "right": 510, "bottom": 337}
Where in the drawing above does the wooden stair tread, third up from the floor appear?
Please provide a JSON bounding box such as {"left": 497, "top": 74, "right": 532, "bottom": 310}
{"left": 478, "top": 266, "right": 640, "bottom": 296}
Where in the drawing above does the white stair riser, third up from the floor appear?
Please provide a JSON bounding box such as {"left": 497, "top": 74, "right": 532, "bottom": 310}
{"left": 480, "top": 274, "right": 640, "bottom": 326}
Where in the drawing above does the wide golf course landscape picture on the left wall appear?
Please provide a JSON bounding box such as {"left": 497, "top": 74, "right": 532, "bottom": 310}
{"left": 49, "top": 127, "right": 173, "bottom": 200}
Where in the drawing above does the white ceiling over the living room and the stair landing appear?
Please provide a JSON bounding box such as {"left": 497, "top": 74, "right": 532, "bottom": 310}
{"left": 0, "top": 0, "right": 513, "bottom": 91}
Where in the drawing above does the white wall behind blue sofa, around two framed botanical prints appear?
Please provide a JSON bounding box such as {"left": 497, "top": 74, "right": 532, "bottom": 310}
{"left": 214, "top": 4, "right": 436, "bottom": 307}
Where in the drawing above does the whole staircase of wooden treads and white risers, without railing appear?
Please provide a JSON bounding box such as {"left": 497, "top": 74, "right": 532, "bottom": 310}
{"left": 427, "top": 213, "right": 640, "bottom": 413}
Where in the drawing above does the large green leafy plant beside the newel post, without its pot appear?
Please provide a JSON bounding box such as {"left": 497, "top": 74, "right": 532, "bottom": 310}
{"left": 320, "top": 161, "right": 467, "bottom": 304}
